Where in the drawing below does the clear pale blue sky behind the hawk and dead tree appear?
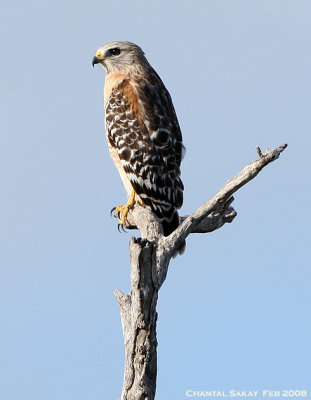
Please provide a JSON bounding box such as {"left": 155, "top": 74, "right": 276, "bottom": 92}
{"left": 0, "top": 0, "right": 311, "bottom": 400}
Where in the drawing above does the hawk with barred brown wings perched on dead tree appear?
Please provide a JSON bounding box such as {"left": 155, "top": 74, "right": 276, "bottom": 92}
{"left": 92, "top": 42, "right": 184, "bottom": 247}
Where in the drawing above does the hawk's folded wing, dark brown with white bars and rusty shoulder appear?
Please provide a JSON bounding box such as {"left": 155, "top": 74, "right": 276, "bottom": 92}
{"left": 106, "top": 70, "right": 184, "bottom": 235}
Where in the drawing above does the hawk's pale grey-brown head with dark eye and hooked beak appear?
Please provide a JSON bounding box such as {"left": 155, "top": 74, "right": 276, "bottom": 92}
{"left": 92, "top": 42, "right": 148, "bottom": 73}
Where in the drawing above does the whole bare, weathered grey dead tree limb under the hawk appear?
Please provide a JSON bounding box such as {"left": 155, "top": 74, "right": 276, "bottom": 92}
{"left": 114, "top": 144, "right": 287, "bottom": 400}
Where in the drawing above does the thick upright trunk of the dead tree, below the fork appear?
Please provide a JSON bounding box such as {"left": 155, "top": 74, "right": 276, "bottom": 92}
{"left": 114, "top": 238, "right": 158, "bottom": 400}
